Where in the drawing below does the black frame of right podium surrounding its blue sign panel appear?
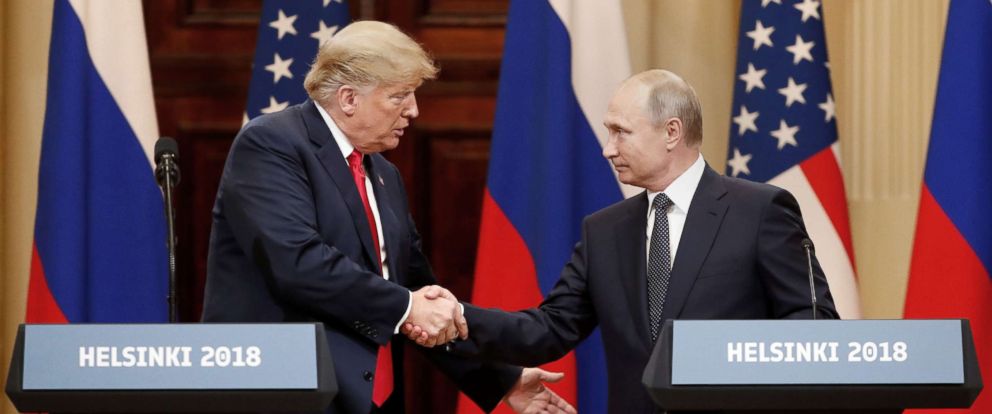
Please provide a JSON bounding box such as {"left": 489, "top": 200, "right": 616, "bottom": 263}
{"left": 643, "top": 320, "right": 982, "bottom": 413}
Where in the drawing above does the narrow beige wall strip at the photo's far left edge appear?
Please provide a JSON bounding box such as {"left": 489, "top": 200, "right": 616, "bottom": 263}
{"left": 0, "top": 0, "right": 53, "bottom": 413}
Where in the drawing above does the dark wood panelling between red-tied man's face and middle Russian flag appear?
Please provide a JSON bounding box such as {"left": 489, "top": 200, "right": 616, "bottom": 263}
{"left": 384, "top": 0, "right": 508, "bottom": 413}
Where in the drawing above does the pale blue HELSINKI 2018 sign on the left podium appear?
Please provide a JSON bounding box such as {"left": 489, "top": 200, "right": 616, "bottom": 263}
{"left": 23, "top": 325, "right": 317, "bottom": 390}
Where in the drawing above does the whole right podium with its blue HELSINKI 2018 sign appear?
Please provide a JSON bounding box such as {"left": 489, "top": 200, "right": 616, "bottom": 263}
{"left": 642, "top": 320, "right": 982, "bottom": 413}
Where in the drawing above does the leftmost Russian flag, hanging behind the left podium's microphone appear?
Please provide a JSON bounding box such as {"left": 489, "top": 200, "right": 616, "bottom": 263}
{"left": 25, "top": 0, "right": 168, "bottom": 323}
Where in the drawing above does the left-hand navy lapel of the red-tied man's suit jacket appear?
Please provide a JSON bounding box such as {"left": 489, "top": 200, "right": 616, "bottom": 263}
{"left": 302, "top": 100, "right": 381, "bottom": 272}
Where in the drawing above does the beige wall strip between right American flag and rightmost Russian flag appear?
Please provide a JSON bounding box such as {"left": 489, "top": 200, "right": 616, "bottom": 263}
{"left": 824, "top": 0, "right": 948, "bottom": 318}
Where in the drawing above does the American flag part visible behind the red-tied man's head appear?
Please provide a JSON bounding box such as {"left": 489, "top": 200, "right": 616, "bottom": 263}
{"left": 244, "top": 0, "right": 351, "bottom": 123}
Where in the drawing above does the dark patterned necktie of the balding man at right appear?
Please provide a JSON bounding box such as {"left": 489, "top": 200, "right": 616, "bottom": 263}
{"left": 648, "top": 193, "right": 672, "bottom": 343}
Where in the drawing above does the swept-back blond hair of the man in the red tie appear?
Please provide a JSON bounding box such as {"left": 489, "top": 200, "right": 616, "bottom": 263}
{"left": 303, "top": 21, "right": 438, "bottom": 103}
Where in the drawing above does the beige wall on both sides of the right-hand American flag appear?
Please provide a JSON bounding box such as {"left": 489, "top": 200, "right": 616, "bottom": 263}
{"left": 624, "top": 0, "right": 947, "bottom": 318}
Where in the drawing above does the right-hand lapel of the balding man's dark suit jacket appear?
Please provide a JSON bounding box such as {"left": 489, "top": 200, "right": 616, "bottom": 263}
{"left": 661, "top": 166, "right": 727, "bottom": 320}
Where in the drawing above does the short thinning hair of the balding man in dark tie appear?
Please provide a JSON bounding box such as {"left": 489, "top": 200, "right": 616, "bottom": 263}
{"left": 632, "top": 69, "right": 703, "bottom": 147}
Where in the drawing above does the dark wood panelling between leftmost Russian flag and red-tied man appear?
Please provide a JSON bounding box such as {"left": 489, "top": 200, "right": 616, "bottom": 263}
{"left": 144, "top": 0, "right": 261, "bottom": 321}
